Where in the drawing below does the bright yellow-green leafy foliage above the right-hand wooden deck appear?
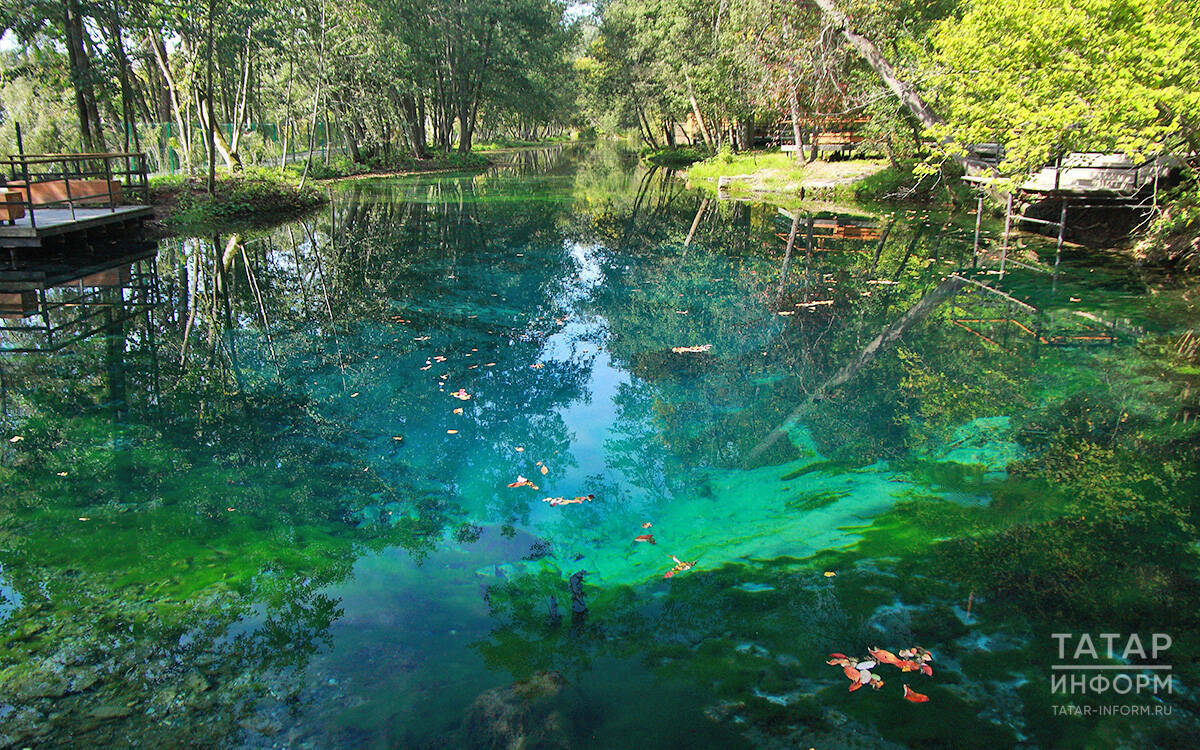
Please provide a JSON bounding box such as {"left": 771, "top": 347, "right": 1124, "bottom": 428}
{"left": 932, "top": 0, "right": 1200, "bottom": 175}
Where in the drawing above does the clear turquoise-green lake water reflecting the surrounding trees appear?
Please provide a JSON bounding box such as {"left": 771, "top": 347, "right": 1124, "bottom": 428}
{"left": 0, "top": 146, "right": 1200, "bottom": 748}
